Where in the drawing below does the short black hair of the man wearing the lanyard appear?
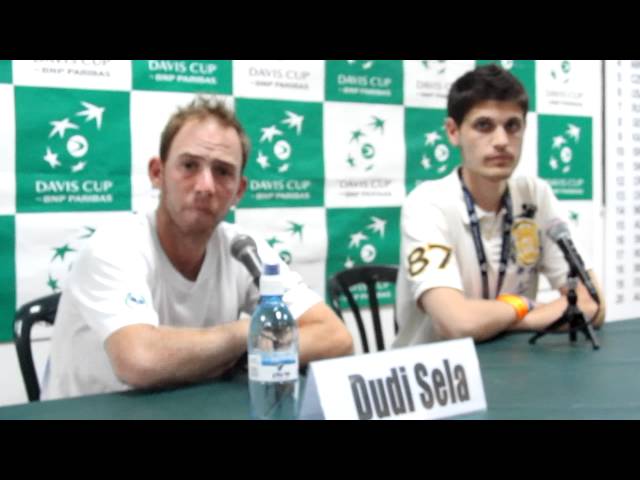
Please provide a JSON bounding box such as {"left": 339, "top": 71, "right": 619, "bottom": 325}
{"left": 447, "top": 64, "right": 529, "bottom": 125}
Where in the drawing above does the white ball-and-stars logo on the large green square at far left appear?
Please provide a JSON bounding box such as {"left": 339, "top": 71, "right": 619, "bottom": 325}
{"left": 43, "top": 101, "right": 105, "bottom": 174}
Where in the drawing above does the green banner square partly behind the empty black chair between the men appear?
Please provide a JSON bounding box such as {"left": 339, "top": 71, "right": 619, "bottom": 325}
{"left": 326, "top": 207, "right": 400, "bottom": 308}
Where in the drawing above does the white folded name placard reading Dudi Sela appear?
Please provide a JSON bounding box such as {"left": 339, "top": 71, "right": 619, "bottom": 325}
{"left": 299, "top": 338, "right": 487, "bottom": 420}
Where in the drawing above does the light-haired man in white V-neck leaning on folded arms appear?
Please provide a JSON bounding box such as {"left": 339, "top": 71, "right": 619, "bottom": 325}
{"left": 42, "top": 97, "right": 353, "bottom": 398}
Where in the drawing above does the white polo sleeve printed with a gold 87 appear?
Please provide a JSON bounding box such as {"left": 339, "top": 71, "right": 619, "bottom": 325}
{"left": 400, "top": 196, "right": 463, "bottom": 300}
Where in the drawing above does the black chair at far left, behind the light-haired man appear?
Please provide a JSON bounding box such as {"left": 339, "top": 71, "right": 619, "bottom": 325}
{"left": 13, "top": 293, "right": 60, "bottom": 402}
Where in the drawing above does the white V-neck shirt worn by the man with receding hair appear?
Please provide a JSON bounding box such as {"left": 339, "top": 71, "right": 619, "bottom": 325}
{"left": 42, "top": 212, "right": 322, "bottom": 399}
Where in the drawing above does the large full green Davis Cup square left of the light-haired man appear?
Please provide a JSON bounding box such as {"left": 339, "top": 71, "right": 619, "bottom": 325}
{"left": 15, "top": 87, "right": 131, "bottom": 212}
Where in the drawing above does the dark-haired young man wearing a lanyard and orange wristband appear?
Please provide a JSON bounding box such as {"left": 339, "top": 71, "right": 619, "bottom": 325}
{"left": 394, "top": 65, "right": 604, "bottom": 347}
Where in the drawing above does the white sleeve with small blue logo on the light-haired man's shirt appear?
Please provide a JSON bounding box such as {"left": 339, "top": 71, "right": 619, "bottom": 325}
{"left": 69, "top": 235, "right": 159, "bottom": 341}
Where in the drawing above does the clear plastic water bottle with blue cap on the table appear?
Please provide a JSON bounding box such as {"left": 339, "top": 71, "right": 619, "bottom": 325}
{"left": 247, "top": 264, "right": 299, "bottom": 420}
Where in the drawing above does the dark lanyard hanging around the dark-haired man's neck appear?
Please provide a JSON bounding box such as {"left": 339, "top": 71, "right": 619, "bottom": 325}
{"left": 458, "top": 169, "right": 513, "bottom": 299}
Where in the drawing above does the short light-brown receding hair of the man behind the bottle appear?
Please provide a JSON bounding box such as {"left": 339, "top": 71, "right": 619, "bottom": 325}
{"left": 160, "top": 95, "right": 251, "bottom": 171}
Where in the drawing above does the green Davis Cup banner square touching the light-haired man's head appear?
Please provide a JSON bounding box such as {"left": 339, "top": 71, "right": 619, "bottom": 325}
{"left": 236, "top": 98, "right": 324, "bottom": 208}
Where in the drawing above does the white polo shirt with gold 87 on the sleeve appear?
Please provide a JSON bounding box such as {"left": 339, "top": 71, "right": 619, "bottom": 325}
{"left": 393, "top": 170, "right": 590, "bottom": 347}
